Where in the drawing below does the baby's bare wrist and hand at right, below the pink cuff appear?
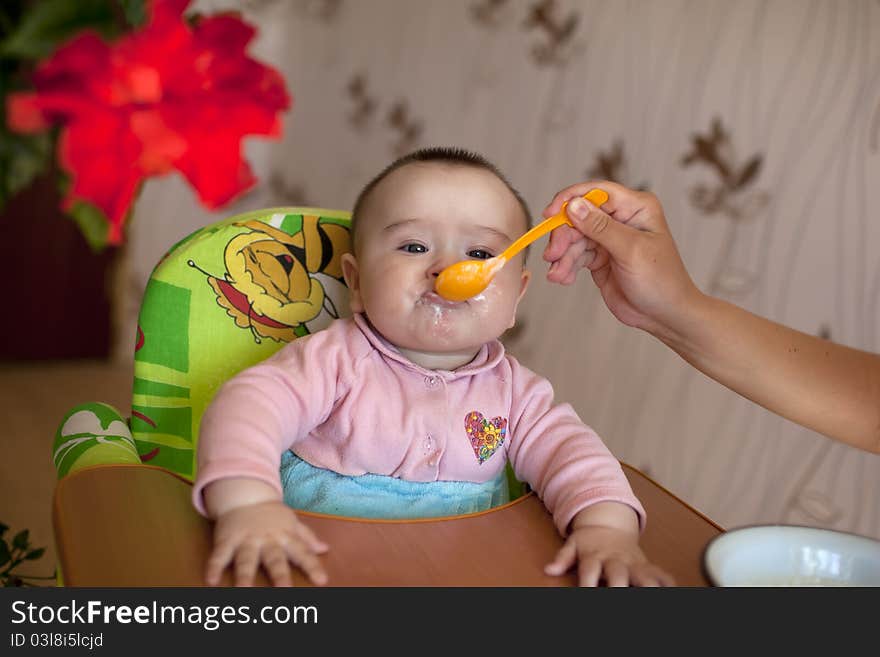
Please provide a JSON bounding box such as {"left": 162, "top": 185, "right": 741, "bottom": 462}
{"left": 545, "top": 502, "right": 675, "bottom": 586}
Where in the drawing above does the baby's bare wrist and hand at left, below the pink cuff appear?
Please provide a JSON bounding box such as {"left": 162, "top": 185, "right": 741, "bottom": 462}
{"left": 204, "top": 478, "right": 328, "bottom": 586}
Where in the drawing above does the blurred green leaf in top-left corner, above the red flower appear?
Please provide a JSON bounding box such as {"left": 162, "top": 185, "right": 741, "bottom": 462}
{"left": 0, "top": 0, "right": 119, "bottom": 59}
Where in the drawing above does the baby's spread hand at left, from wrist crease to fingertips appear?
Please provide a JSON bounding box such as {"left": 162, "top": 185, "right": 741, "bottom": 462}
{"left": 205, "top": 501, "right": 328, "bottom": 586}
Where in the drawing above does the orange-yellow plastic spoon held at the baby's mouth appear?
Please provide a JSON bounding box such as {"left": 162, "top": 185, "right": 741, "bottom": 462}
{"left": 434, "top": 189, "right": 608, "bottom": 301}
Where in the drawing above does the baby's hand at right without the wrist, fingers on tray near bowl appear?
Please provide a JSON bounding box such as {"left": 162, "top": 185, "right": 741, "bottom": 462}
{"left": 544, "top": 525, "right": 675, "bottom": 586}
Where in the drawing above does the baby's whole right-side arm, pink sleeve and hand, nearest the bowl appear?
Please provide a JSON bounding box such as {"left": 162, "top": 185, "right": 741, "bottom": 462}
{"left": 508, "top": 360, "right": 672, "bottom": 586}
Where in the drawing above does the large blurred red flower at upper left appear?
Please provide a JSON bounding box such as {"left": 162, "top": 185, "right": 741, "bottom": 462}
{"left": 7, "top": 0, "right": 290, "bottom": 244}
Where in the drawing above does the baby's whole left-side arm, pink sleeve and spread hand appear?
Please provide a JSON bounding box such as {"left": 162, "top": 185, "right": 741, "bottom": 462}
{"left": 192, "top": 329, "right": 352, "bottom": 585}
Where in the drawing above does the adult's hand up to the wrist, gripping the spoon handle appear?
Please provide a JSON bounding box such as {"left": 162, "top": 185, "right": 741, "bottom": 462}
{"left": 544, "top": 181, "right": 701, "bottom": 335}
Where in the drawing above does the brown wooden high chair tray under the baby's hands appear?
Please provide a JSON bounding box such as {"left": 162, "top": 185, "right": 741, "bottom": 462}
{"left": 53, "top": 464, "right": 722, "bottom": 587}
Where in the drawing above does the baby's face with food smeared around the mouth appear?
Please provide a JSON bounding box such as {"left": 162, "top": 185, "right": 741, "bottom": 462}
{"left": 343, "top": 162, "right": 529, "bottom": 369}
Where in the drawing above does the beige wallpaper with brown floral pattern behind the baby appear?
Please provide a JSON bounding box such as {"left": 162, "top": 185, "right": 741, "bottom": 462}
{"left": 118, "top": 0, "right": 880, "bottom": 537}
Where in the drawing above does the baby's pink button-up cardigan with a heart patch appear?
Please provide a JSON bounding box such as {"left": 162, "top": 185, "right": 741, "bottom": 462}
{"left": 193, "top": 315, "right": 645, "bottom": 534}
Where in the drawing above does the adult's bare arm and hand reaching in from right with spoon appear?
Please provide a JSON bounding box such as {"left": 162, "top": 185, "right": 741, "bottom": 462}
{"left": 544, "top": 181, "right": 880, "bottom": 453}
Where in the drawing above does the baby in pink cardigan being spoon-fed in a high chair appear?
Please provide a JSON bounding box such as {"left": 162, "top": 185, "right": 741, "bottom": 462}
{"left": 193, "top": 148, "right": 672, "bottom": 586}
